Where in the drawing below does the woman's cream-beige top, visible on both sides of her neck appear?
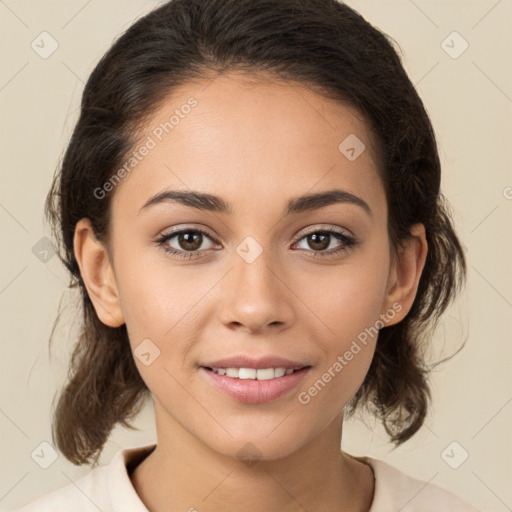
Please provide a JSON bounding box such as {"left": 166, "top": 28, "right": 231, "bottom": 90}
{"left": 12, "top": 444, "right": 479, "bottom": 512}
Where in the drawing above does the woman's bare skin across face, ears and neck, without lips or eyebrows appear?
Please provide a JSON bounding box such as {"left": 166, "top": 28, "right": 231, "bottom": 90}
{"left": 75, "top": 72, "right": 427, "bottom": 512}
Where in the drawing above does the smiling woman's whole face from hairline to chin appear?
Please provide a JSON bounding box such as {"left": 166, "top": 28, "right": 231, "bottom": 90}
{"left": 77, "top": 74, "right": 420, "bottom": 459}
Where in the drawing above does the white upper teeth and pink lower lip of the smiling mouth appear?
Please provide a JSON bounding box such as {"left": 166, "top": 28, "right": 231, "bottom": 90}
{"left": 200, "top": 365, "right": 312, "bottom": 404}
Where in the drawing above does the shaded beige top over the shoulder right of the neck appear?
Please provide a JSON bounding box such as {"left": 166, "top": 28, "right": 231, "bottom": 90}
{"left": 354, "top": 457, "right": 480, "bottom": 512}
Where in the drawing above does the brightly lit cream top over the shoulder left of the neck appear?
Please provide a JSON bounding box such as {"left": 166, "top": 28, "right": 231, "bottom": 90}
{"left": 11, "top": 445, "right": 153, "bottom": 512}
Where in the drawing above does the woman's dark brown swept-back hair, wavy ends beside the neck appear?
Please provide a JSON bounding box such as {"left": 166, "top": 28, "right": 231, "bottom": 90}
{"left": 45, "top": 0, "right": 466, "bottom": 464}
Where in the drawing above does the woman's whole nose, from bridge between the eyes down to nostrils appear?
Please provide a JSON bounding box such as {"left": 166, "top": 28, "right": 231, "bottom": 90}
{"left": 218, "top": 237, "right": 293, "bottom": 330}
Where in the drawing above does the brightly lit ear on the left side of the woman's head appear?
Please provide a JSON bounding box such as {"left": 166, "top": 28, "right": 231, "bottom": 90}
{"left": 73, "top": 218, "right": 125, "bottom": 327}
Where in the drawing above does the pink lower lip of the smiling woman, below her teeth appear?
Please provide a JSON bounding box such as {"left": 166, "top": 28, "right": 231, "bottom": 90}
{"left": 201, "top": 367, "right": 311, "bottom": 404}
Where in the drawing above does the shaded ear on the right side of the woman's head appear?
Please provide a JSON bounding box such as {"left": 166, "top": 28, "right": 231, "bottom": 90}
{"left": 381, "top": 224, "right": 428, "bottom": 326}
